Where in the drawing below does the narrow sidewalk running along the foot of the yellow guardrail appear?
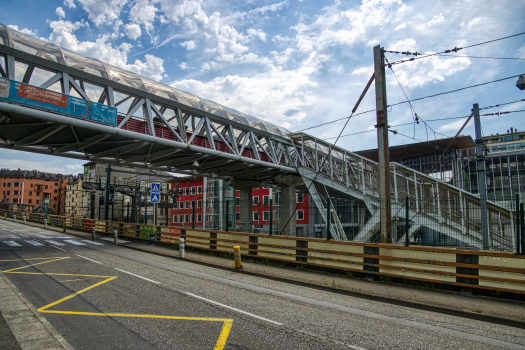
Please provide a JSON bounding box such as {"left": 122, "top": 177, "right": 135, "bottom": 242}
{"left": 5, "top": 217, "right": 525, "bottom": 328}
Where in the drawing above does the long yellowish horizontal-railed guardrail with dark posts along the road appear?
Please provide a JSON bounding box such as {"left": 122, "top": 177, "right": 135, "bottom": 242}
{"left": 0, "top": 211, "right": 525, "bottom": 295}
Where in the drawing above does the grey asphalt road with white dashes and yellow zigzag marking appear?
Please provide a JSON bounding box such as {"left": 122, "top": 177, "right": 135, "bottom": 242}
{"left": 0, "top": 221, "right": 525, "bottom": 350}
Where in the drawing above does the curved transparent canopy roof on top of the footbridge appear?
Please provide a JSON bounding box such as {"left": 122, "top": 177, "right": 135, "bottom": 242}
{"left": 0, "top": 24, "right": 291, "bottom": 136}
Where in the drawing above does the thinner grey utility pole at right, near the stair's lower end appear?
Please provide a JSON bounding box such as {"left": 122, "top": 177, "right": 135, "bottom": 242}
{"left": 473, "top": 103, "right": 490, "bottom": 250}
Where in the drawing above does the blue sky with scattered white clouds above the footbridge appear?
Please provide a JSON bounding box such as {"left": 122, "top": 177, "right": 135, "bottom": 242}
{"left": 0, "top": 0, "right": 525, "bottom": 173}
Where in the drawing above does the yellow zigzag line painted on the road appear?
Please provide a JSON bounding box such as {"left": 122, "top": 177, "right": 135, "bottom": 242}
{"left": 0, "top": 257, "right": 233, "bottom": 350}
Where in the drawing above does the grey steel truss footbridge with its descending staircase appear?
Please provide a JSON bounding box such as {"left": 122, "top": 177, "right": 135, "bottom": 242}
{"left": 0, "top": 24, "right": 513, "bottom": 248}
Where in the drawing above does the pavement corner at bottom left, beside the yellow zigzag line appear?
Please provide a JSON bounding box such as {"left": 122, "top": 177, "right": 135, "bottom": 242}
{"left": 0, "top": 272, "right": 73, "bottom": 350}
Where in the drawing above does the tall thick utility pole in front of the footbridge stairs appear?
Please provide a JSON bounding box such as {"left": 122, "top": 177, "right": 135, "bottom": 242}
{"left": 374, "top": 45, "right": 392, "bottom": 243}
